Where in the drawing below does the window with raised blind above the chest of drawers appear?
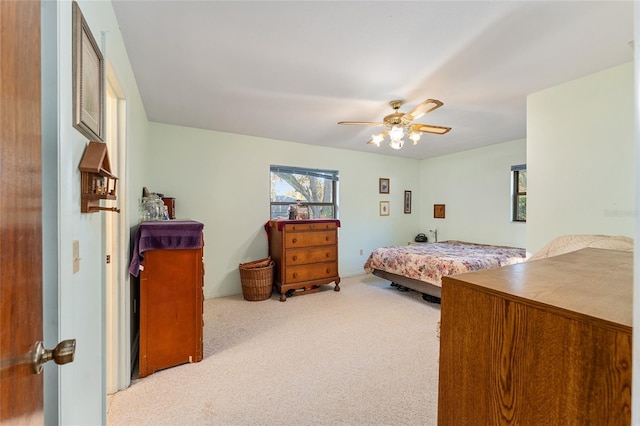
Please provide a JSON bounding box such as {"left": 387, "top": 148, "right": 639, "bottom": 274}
{"left": 271, "top": 166, "right": 338, "bottom": 219}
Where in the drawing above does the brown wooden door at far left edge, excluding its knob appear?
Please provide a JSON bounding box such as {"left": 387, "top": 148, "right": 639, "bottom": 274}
{"left": 0, "top": 0, "right": 44, "bottom": 424}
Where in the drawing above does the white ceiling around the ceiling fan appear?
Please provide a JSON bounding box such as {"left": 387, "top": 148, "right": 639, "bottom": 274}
{"left": 113, "top": 0, "right": 633, "bottom": 159}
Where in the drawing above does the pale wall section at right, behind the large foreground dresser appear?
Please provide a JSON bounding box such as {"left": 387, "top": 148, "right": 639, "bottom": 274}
{"left": 527, "top": 63, "right": 637, "bottom": 253}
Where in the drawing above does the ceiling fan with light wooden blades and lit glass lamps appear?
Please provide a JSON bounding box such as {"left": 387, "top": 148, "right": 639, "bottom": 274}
{"left": 338, "top": 99, "right": 451, "bottom": 149}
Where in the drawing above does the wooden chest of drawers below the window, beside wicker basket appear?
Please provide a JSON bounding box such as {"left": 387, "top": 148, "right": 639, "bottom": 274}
{"left": 266, "top": 219, "right": 340, "bottom": 302}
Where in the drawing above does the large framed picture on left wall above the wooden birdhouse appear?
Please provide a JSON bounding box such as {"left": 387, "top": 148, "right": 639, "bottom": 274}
{"left": 72, "top": 1, "right": 104, "bottom": 142}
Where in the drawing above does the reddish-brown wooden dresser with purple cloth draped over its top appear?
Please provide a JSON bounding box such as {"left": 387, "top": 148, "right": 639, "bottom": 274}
{"left": 130, "top": 221, "right": 204, "bottom": 378}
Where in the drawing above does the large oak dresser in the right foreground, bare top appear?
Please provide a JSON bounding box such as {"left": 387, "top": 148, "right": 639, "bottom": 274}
{"left": 438, "top": 248, "right": 633, "bottom": 426}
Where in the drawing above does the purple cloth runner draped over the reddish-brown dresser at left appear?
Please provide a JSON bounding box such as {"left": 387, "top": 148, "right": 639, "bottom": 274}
{"left": 129, "top": 220, "right": 204, "bottom": 277}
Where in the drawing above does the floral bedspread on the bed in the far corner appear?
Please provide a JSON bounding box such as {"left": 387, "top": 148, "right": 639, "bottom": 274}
{"left": 364, "top": 241, "right": 526, "bottom": 286}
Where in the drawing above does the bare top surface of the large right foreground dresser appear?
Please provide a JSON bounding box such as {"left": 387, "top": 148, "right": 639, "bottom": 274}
{"left": 443, "top": 248, "right": 633, "bottom": 333}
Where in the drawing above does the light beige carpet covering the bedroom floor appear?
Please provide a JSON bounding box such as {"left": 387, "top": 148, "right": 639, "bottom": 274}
{"left": 107, "top": 275, "right": 440, "bottom": 425}
